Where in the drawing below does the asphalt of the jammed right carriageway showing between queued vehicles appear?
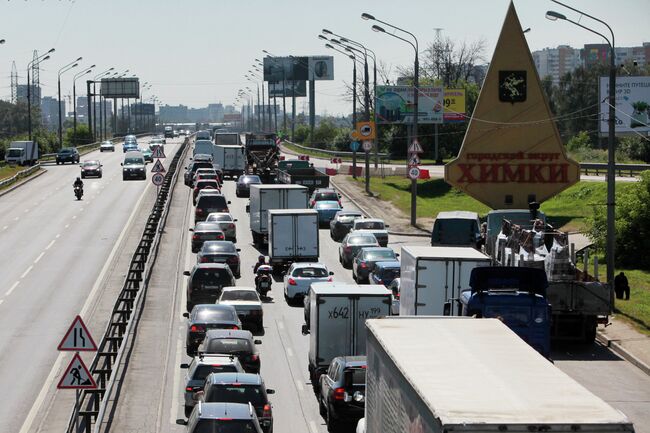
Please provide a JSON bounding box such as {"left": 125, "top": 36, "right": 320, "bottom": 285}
{"left": 102, "top": 150, "right": 650, "bottom": 433}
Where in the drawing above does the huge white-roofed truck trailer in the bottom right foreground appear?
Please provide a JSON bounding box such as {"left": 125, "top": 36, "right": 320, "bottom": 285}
{"left": 364, "top": 317, "right": 634, "bottom": 433}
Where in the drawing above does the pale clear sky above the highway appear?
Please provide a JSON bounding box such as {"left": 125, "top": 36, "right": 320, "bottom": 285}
{"left": 0, "top": 0, "right": 650, "bottom": 114}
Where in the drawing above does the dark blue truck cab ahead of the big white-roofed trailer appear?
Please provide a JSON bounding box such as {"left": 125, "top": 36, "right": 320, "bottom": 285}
{"left": 460, "top": 266, "right": 551, "bottom": 358}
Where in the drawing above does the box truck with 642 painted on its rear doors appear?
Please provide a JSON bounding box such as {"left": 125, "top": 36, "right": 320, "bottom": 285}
{"left": 302, "top": 282, "right": 391, "bottom": 391}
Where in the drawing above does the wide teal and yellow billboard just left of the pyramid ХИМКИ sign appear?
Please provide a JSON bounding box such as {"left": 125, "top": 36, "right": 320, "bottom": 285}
{"left": 376, "top": 86, "right": 443, "bottom": 124}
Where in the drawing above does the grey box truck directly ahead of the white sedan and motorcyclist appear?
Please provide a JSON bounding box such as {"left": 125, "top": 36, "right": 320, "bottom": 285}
{"left": 267, "top": 209, "right": 319, "bottom": 273}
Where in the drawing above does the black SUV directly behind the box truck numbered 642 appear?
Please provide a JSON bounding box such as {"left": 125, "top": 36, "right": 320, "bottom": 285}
{"left": 318, "top": 356, "right": 367, "bottom": 432}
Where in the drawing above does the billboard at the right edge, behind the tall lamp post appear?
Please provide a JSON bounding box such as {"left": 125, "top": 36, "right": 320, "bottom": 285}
{"left": 599, "top": 77, "right": 650, "bottom": 134}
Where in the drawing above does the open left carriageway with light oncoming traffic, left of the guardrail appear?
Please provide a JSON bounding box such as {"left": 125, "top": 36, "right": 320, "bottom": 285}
{"left": 0, "top": 138, "right": 185, "bottom": 433}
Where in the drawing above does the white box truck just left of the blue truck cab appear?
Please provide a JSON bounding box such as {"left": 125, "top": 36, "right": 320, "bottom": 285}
{"left": 399, "top": 246, "right": 490, "bottom": 316}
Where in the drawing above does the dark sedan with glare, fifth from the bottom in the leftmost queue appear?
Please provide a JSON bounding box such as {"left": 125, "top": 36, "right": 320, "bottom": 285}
{"left": 183, "top": 304, "right": 242, "bottom": 356}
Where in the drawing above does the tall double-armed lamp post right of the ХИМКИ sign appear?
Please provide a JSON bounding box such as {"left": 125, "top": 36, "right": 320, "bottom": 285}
{"left": 546, "top": 0, "right": 616, "bottom": 293}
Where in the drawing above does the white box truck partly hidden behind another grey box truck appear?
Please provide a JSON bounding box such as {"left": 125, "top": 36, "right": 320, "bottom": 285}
{"left": 249, "top": 185, "right": 309, "bottom": 246}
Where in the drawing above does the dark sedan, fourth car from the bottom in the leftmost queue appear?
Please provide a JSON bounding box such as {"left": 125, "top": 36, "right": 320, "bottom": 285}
{"left": 198, "top": 329, "right": 262, "bottom": 373}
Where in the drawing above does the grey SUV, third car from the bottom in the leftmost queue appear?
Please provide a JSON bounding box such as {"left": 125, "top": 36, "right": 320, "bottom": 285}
{"left": 181, "top": 355, "right": 244, "bottom": 417}
